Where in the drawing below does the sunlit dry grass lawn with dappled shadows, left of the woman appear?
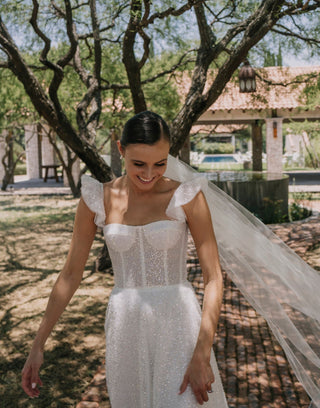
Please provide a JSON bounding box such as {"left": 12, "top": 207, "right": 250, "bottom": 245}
{"left": 0, "top": 196, "right": 113, "bottom": 408}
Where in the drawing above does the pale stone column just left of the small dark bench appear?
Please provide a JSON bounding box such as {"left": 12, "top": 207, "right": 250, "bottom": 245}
{"left": 24, "top": 124, "right": 41, "bottom": 179}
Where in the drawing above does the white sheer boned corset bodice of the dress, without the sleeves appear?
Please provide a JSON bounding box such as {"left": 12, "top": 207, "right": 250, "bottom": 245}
{"left": 103, "top": 220, "right": 187, "bottom": 287}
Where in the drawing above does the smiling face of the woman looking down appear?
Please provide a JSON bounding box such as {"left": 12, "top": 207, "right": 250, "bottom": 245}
{"left": 118, "top": 138, "right": 170, "bottom": 191}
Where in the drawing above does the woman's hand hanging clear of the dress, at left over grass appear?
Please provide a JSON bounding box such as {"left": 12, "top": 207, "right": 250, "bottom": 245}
{"left": 21, "top": 350, "right": 43, "bottom": 398}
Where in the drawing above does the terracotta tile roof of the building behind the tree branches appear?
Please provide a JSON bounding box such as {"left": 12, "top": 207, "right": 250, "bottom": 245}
{"left": 176, "top": 66, "right": 320, "bottom": 111}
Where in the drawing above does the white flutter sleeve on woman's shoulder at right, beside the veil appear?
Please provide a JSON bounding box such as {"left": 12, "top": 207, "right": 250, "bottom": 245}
{"left": 166, "top": 177, "right": 208, "bottom": 221}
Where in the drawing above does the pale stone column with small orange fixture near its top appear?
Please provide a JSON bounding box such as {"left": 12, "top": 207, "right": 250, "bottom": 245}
{"left": 265, "top": 118, "right": 283, "bottom": 173}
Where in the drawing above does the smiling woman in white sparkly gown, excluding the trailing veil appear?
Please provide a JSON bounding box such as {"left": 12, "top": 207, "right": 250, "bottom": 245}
{"left": 22, "top": 111, "right": 227, "bottom": 408}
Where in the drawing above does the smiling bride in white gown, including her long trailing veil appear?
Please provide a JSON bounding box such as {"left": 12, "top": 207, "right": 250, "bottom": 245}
{"left": 22, "top": 112, "right": 320, "bottom": 408}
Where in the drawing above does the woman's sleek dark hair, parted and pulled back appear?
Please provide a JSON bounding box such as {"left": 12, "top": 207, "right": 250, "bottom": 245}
{"left": 120, "top": 111, "right": 170, "bottom": 147}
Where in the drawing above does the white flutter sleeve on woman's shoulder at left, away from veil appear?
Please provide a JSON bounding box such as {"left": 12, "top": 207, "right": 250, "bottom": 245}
{"left": 81, "top": 174, "right": 106, "bottom": 228}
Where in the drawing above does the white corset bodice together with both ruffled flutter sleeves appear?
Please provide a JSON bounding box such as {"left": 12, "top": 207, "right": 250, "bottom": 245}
{"left": 81, "top": 175, "right": 207, "bottom": 288}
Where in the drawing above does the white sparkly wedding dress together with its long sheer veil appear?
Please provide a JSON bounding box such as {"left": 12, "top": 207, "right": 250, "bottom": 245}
{"left": 82, "top": 155, "right": 320, "bottom": 408}
